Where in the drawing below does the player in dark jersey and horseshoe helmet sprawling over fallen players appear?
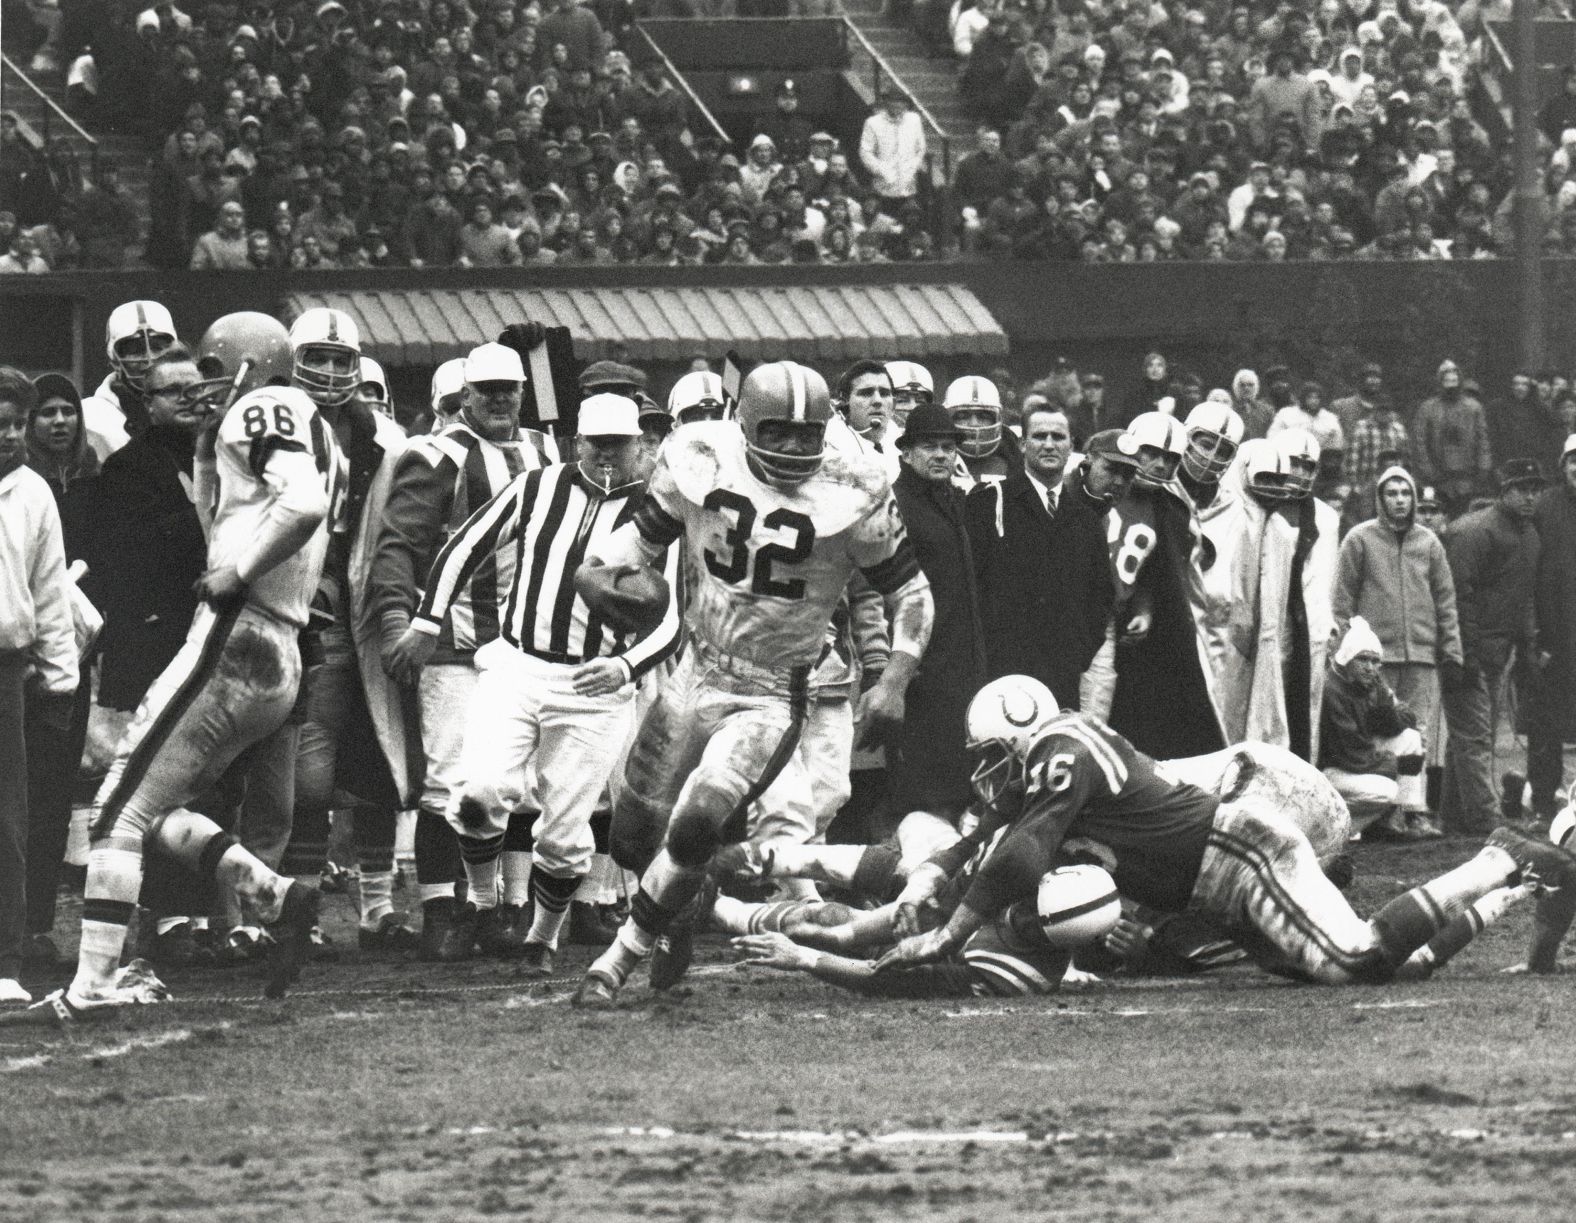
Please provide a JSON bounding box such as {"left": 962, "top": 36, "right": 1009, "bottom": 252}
{"left": 878, "top": 676, "right": 1576, "bottom": 983}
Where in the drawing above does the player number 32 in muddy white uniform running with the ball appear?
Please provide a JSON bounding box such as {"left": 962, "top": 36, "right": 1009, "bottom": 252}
{"left": 575, "top": 361, "right": 933, "bottom": 1009}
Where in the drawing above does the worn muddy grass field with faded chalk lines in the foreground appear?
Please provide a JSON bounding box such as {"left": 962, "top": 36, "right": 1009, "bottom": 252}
{"left": 0, "top": 840, "right": 1576, "bottom": 1223}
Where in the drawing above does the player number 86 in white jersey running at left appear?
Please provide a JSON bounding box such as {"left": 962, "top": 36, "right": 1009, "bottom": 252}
{"left": 13, "top": 315, "right": 342, "bottom": 1024}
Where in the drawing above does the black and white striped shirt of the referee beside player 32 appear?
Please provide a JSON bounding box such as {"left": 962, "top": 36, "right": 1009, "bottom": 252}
{"left": 411, "top": 463, "right": 679, "bottom": 679}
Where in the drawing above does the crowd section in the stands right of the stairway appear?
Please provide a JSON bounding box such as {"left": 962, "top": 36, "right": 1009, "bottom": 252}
{"left": 914, "top": 0, "right": 1576, "bottom": 263}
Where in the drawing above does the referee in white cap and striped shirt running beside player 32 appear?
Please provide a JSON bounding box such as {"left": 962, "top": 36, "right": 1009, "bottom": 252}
{"left": 390, "top": 394, "right": 679, "bottom": 976}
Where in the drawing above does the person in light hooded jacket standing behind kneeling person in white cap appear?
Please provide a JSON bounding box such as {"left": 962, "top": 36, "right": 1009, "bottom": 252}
{"left": 1333, "top": 467, "right": 1463, "bottom": 832}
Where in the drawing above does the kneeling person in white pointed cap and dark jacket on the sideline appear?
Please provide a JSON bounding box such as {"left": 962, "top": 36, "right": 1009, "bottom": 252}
{"left": 1319, "top": 616, "right": 1423, "bottom": 840}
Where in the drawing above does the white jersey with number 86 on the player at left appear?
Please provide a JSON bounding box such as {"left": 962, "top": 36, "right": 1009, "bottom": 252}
{"left": 208, "top": 386, "right": 348, "bottom": 627}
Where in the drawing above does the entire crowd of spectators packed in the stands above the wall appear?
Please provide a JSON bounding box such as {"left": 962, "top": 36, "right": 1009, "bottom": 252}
{"left": 0, "top": 0, "right": 1576, "bottom": 271}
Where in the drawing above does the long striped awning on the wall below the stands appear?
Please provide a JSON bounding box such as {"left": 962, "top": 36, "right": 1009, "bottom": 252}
{"left": 285, "top": 284, "right": 1007, "bottom": 366}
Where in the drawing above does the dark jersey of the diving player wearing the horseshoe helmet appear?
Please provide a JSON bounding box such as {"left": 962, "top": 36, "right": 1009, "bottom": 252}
{"left": 966, "top": 714, "right": 1218, "bottom": 914}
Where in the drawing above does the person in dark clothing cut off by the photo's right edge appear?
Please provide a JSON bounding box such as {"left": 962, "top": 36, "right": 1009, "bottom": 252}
{"left": 1527, "top": 433, "right": 1576, "bottom": 820}
